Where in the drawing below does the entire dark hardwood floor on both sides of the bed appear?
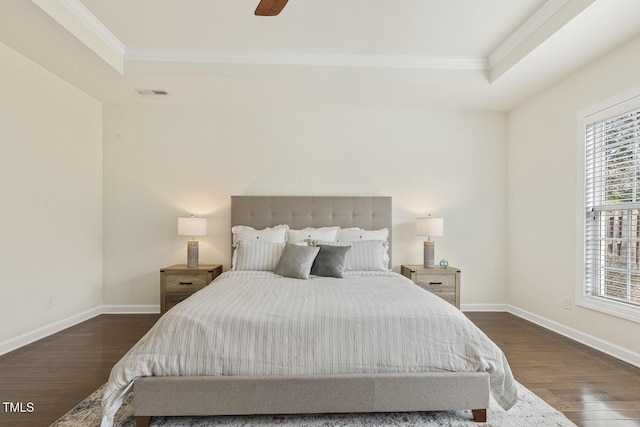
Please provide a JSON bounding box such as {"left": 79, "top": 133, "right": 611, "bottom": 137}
{"left": 0, "top": 313, "right": 640, "bottom": 427}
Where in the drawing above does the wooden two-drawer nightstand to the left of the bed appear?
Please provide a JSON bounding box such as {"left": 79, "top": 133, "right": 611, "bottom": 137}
{"left": 160, "top": 264, "right": 222, "bottom": 314}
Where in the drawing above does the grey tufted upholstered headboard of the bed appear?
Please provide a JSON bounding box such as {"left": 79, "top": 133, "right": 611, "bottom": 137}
{"left": 231, "top": 196, "right": 392, "bottom": 264}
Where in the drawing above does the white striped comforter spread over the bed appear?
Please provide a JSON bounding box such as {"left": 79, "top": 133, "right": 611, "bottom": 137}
{"left": 102, "top": 272, "right": 517, "bottom": 427}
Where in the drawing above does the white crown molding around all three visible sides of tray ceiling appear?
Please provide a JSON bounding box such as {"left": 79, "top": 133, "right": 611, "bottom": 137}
{"left": 37, "top": 0, "right": 584, "bottom": 73}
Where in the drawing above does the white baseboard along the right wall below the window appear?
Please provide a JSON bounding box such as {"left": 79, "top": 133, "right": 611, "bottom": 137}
{"left": 507, "top": 305, "right": 640, "bottom": 368}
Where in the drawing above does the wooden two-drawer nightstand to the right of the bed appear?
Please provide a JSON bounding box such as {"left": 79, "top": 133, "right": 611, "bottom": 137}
{"left": 400, "top": 265, "right": 460, "bottom": 309}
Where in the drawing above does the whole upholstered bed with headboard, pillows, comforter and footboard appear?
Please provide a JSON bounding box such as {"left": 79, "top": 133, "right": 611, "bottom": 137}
{"left": 102, "top": 196, "right": 517, "bottom": 427}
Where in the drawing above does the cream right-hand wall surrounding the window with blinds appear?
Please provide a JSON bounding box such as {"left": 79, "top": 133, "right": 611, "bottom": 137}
{"left": 508, "top": 38, "right": 640, "bottom": 354}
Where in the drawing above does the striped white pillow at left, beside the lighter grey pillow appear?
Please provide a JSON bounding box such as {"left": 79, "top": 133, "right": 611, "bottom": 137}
{"left": 231, "top": 240, "right": 284, "bottom": 271}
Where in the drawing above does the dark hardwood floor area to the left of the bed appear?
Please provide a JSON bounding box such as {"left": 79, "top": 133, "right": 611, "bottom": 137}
{"left": 0, "top": 314, "right": 160, "bottom": 427}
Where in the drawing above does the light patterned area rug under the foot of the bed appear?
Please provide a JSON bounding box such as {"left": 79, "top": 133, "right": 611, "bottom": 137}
{"left": 52, "top": 383, "right": 575, "bottom": 427}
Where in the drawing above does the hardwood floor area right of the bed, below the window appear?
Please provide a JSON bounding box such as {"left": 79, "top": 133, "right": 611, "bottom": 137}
{"left": 465, "top": 313, "right": 640, "bottom": 427}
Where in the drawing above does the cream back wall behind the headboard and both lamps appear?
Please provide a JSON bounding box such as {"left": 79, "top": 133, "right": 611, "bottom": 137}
{"left": 104, "top": 102, "right": 507, "bottom": 306}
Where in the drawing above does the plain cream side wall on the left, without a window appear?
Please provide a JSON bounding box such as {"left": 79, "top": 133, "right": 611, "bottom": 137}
{"left": 0, "top": 44, "right": 102, "bottom": 350}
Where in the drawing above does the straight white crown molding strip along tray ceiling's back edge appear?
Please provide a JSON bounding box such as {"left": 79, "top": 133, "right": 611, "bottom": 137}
{"left": 124, "top": 47, "right": 488, "bottom": 70}
